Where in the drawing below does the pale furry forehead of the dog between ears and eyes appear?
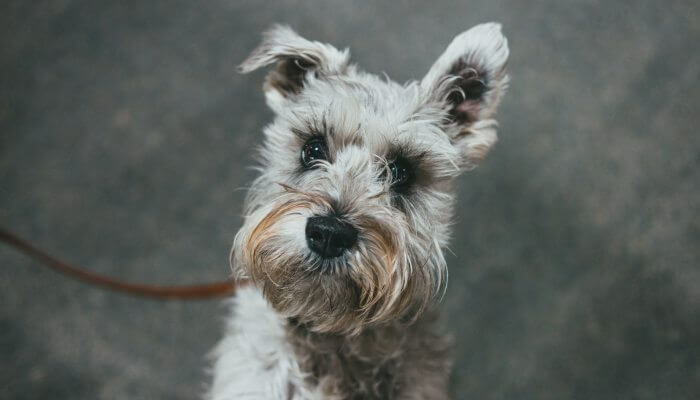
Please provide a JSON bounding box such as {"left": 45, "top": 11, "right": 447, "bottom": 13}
{"left": 294, "top": 74, "right": 458, "bottom": 159}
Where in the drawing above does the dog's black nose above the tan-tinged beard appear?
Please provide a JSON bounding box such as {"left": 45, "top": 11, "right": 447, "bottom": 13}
{"left": 306, "top": 216, "right": 357, "bottom": 258}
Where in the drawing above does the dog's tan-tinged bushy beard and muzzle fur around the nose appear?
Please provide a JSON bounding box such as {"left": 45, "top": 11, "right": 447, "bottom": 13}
{"left": 232, "top": 192, "right": 444, "bottom": 334}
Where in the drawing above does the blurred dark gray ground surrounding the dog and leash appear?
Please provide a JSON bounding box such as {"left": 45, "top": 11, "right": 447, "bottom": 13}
{"left": 0, "top": 0, "right": 700, "bottom": 399}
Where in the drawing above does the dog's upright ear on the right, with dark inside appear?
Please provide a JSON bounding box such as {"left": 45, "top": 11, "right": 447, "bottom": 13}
{"left": 421, "top": 23, "right": 509, "bottom": 168}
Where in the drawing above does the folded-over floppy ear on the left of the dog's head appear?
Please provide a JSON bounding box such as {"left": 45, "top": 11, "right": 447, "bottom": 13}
{"left": 238, "top": 25, "right": 350, "bottom": 98}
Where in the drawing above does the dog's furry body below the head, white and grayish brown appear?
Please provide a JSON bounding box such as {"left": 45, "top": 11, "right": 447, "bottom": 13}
{"left": 211, "top": 288, "right": 449, "bottom": 400}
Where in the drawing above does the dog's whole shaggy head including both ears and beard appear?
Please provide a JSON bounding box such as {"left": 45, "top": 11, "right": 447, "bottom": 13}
{"left": 231, "top": 24, "right": 508, "bottom": 333}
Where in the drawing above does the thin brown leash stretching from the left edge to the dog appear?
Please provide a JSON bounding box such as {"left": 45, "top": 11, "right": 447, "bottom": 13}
{"left": 0, "top": 228, "right": 247, "bottom": 300}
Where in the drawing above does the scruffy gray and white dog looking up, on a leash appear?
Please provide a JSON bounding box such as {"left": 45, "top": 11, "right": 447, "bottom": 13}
{"left": 207, "top": 23, "right": 508, "bottom": 400}
